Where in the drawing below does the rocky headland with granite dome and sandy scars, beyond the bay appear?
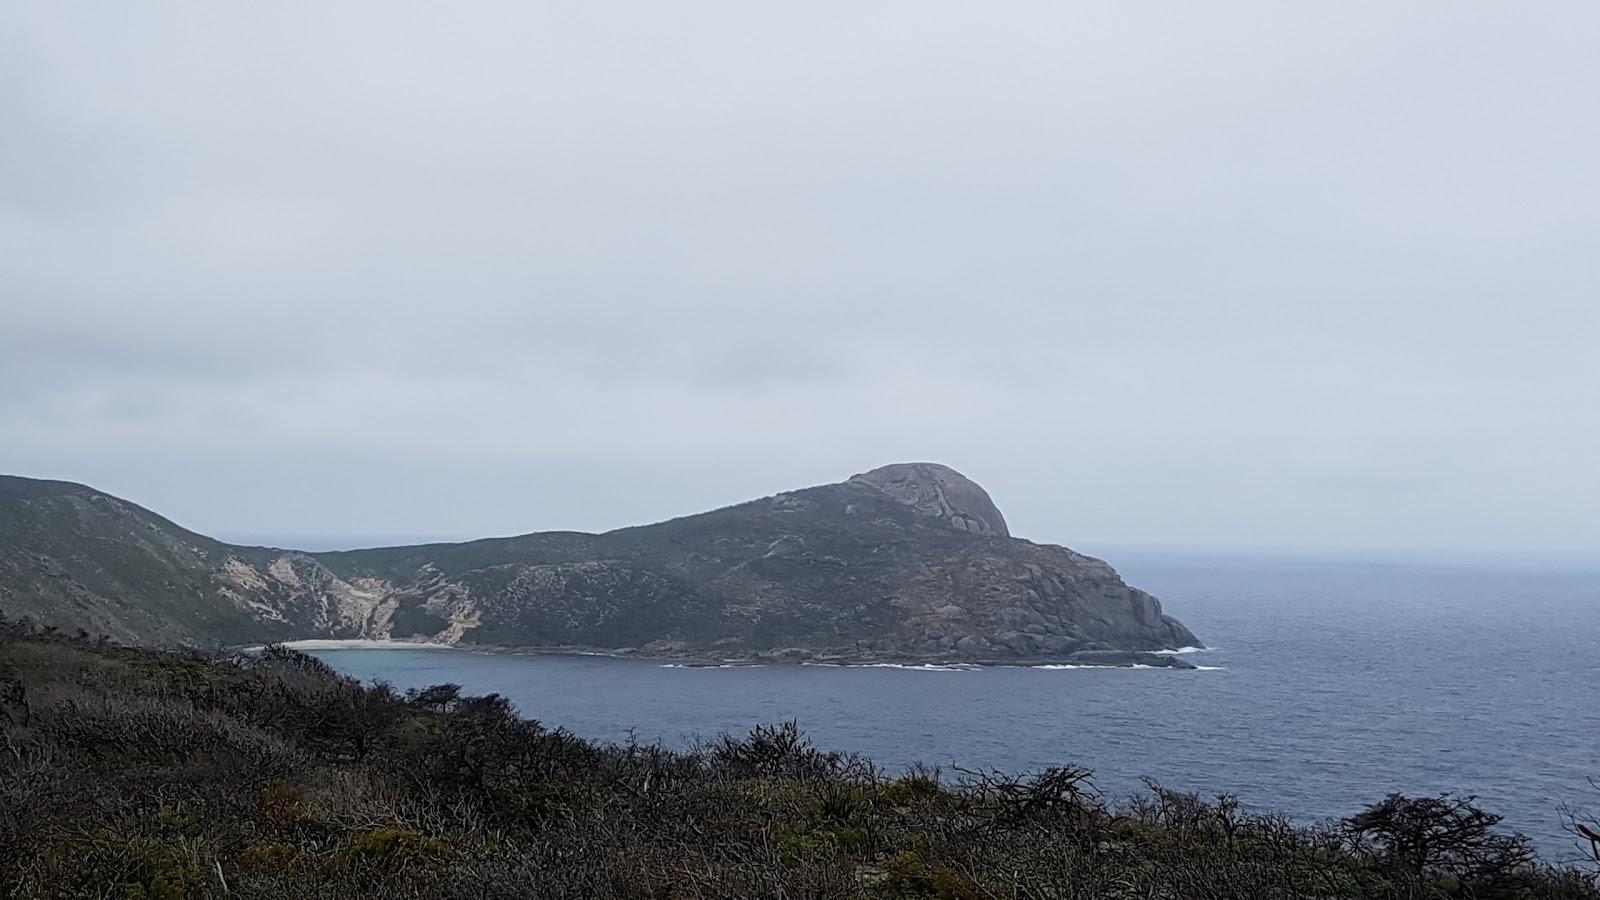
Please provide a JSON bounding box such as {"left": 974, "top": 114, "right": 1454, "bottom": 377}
{"left": 0, "top": 463, "right": 1200, "bottom": 666}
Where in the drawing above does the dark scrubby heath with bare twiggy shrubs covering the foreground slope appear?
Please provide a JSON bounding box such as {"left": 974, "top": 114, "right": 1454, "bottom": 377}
{"left": 0, "top": 614, "right": 1600, "bottom": 900}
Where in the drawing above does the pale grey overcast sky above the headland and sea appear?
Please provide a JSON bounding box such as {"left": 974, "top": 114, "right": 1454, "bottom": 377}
{"left": 0, "top": 0, "right": 1600, "bottom": 559}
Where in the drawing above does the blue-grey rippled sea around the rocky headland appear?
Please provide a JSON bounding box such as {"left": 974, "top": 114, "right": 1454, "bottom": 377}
{"left": 308, "top": 559, "right": 1600, "bottom": 858}
